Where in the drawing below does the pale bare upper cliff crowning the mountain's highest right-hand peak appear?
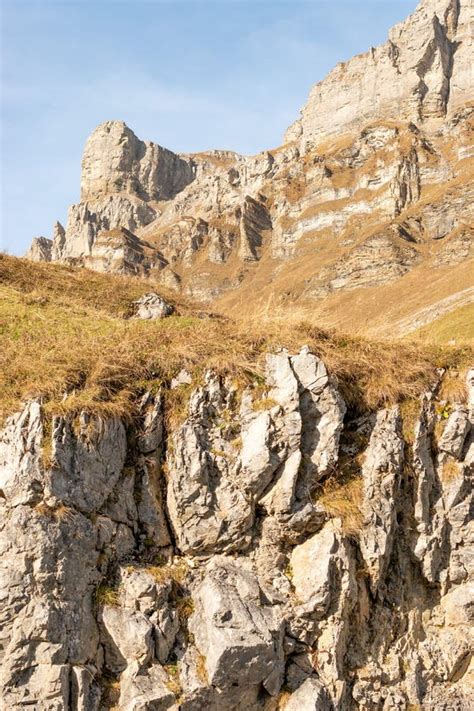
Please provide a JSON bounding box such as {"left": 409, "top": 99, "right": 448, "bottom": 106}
{"left": 287, "top": 0, "right": 474, "bottom": 147}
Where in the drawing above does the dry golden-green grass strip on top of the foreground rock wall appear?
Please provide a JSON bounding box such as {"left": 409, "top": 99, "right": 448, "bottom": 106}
{"left": 0, "top": 255, "right": 472, "bottom": 426}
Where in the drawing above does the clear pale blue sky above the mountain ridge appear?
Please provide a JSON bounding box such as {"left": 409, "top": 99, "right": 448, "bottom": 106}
{"left": 0, "top": 0, "right": 417, "bottom": 254}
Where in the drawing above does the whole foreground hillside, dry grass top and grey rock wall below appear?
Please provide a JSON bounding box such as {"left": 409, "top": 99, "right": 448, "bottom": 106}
{"left": 0, "top": 255, "right": 474, "bottom": 711}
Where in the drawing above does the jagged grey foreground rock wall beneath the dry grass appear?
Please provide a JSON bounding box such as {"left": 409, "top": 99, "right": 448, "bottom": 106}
{"left": 0, "top": 349, "right": 474, "bottom": 711}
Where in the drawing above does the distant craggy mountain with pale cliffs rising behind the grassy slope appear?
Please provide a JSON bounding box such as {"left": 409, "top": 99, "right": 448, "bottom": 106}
{"left": 28, "top": 0, "right": 474, "bottom": 335}
